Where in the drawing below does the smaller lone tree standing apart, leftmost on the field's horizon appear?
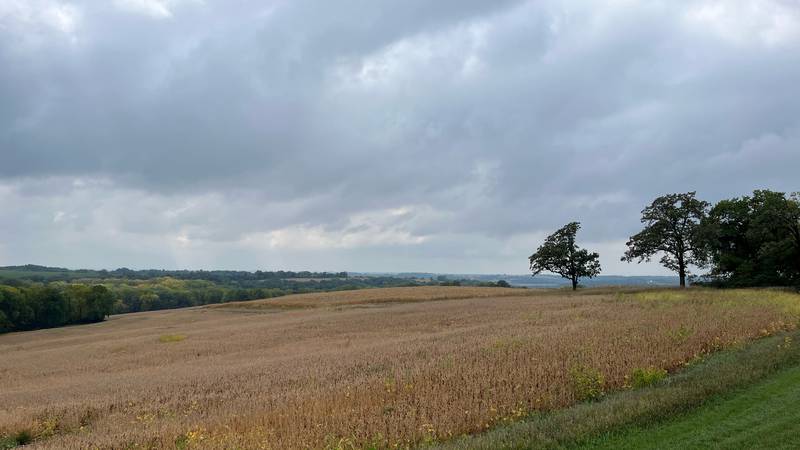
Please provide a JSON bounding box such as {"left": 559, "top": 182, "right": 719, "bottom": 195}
{"left": 528, "top": 222, "right": 600, "bottom": 290}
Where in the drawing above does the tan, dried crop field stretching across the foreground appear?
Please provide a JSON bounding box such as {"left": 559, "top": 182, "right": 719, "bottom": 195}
{"left": 0, "top": 287, "right": 800, "bottom": 448}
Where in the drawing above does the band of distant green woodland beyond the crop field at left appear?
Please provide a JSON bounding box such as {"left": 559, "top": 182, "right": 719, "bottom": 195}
{"left": 0, "top": 265, "right": 440, "bottom": 333}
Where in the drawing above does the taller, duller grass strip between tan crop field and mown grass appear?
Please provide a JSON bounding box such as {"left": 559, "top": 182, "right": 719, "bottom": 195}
{"left": 438, "top": 332, "right": 800, "bottom": 449}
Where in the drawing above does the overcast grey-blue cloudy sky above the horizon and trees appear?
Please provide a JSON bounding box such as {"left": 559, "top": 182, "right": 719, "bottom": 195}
{"left": 0, "top": 0, "right": 800, "bottom": 274}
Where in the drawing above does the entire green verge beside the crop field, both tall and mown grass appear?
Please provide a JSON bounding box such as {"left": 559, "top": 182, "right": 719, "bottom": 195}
{"left": 439, "top": 332, "right": 800, "bottom": 449}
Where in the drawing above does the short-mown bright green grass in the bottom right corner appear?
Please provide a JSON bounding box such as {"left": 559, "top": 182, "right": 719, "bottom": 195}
{"left": 584, "top": 366, "right": 800, "bottom": 449}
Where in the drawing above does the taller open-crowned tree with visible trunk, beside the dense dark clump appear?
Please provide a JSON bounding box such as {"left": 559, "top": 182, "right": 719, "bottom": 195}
{"left": 622, "top": 192, "right": 709, "bottom": 286}
